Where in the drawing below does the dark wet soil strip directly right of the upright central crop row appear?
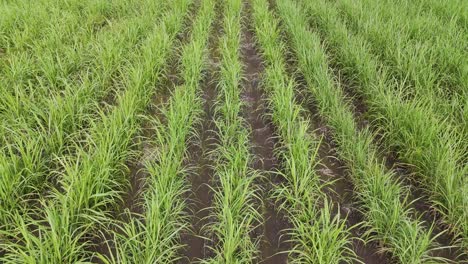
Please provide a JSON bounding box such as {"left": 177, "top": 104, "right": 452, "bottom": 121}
{"left": 241, "top": 21, "right": 291, "bottom": 264}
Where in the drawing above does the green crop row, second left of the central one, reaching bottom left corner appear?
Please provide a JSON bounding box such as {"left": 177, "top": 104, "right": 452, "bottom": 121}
{"left": 2, "top": 1, "right": 190, "bottom": 263}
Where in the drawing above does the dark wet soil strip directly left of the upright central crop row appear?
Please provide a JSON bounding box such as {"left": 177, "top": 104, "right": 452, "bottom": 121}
{"left": 179, "top": 2, "right": 222, "bottom": 263}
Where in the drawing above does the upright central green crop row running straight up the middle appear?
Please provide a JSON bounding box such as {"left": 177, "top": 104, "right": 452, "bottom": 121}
{"left": 206, "top": 0, "right": 261, "bottom": 263}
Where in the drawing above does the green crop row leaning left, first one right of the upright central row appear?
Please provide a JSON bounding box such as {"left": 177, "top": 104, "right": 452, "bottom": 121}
{"left": 252, "top": 0, "right": 354, "bottom": 263}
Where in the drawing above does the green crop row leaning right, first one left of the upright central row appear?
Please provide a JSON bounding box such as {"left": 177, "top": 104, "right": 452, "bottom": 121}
{"left": 106, "top": 0, "right": 214, "bottom": 263}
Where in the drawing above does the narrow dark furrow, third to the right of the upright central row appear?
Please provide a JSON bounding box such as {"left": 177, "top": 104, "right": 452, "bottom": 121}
{"left": 298, "top": 0, "right": 461, "bottom": 256}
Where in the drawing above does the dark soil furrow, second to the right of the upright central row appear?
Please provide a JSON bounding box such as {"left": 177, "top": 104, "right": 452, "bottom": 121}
{"left": 270, "top": 7, "right": 390, "bottom": 258}
